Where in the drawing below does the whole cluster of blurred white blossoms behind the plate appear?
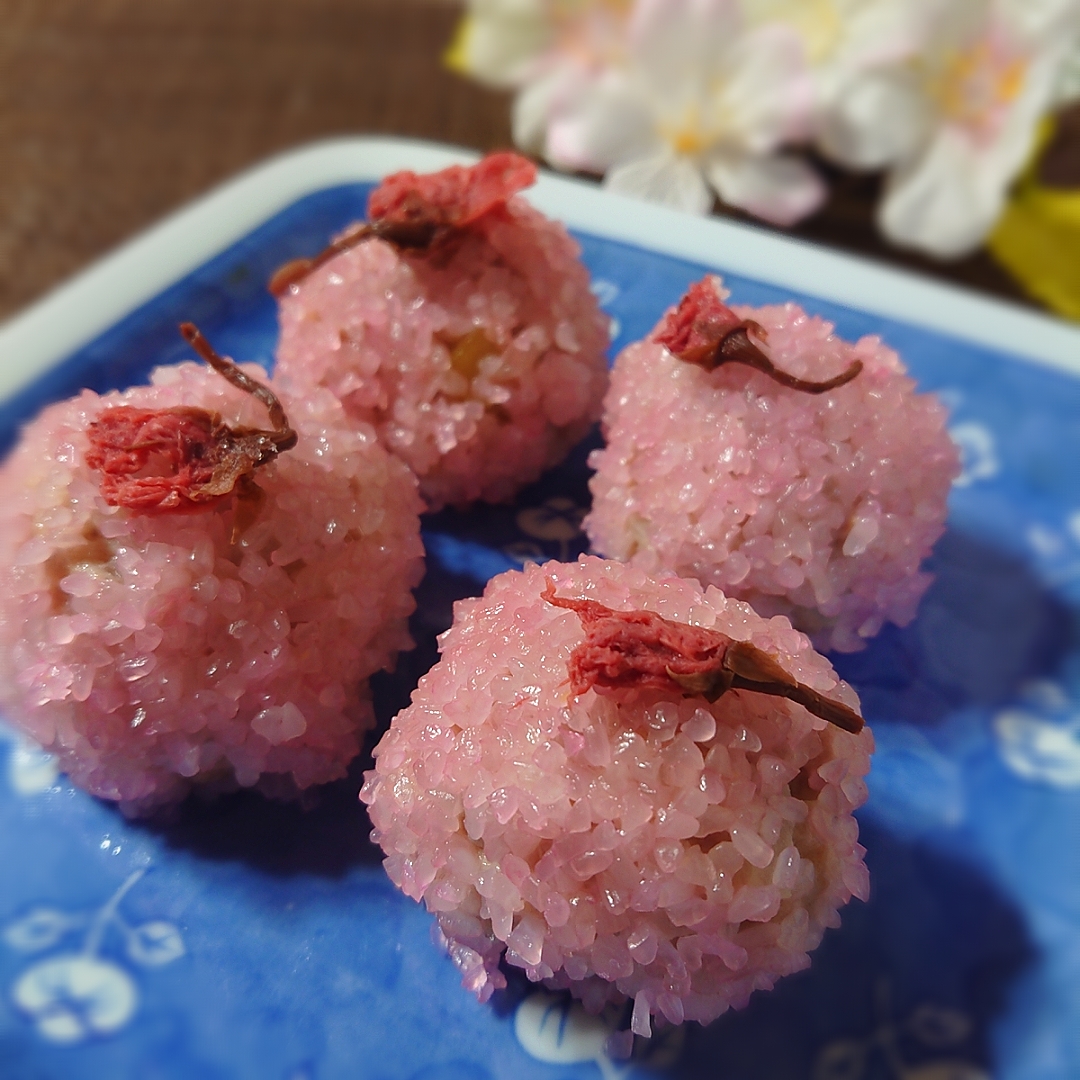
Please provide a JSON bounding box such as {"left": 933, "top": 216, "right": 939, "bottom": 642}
{"left": 451, "top": 0, "right": 1080, "bottom": 245}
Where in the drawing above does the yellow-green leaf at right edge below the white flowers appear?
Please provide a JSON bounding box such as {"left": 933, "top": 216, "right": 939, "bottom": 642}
{"left": 987, "top": 120, "right": 1080, "bottom": 320}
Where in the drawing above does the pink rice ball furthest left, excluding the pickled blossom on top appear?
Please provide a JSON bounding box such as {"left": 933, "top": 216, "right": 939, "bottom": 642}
{"left": 0, "top": 363, "right": 423, "bottom": 812}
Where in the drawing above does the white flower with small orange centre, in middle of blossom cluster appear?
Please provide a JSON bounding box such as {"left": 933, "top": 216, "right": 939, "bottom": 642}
{"left": 544, "top": 0, "right": 824, "bottom": 225}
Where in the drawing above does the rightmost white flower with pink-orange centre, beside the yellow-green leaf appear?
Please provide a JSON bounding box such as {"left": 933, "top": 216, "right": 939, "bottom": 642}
{"left": 832, "top": 0, "right": 1080, "bottom": 257}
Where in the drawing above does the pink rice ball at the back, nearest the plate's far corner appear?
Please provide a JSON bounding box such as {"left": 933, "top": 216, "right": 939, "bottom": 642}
{"left": 276, "top": 154, "right": 608, "bottom": 510}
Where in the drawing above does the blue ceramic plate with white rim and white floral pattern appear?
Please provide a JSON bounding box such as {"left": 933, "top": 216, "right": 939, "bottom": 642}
{"left": 0, "top": 139, "right": 1080, "bottom": 1080}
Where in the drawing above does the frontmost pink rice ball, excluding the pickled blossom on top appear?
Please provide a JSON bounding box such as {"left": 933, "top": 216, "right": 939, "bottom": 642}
{"left": 361, "top": 556, "right": 874, "bottom": 1035}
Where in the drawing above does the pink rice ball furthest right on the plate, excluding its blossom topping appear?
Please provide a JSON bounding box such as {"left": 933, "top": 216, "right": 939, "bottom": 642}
{"left": 584, "top": 276, "right": 959, "bottom": 652}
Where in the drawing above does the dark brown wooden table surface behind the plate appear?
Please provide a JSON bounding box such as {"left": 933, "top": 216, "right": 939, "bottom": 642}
{"left": 0, "top": 0, "right": 1045, "bottom": 318}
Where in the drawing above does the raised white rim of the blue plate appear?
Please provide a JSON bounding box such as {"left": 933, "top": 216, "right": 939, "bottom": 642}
{"left": 0, "top": 136, "right": 1080, "bottom": 400}
